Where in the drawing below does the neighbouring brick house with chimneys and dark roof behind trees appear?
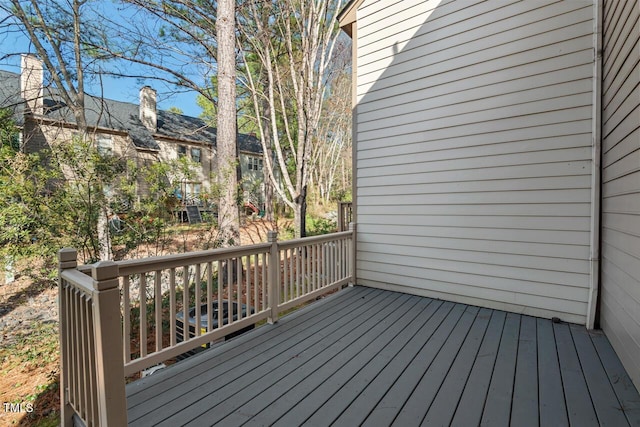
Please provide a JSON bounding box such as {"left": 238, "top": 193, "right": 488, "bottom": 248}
{"left": 0, "top": 55, "right": 264, "bottom": 212}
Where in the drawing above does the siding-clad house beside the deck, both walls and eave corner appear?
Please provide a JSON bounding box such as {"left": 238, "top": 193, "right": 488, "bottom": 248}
{"left": 340, "top": 0, "right": 640, "bottom": 387}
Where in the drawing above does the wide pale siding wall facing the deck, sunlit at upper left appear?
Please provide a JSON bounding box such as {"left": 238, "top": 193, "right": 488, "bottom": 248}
{"left": 356, "top": 0, "right": 594, "bottom": 323}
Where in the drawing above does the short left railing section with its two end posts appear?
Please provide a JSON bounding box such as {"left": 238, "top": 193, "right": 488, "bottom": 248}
{"left": 58, "top": 249, "right": 127, "bottom": 427}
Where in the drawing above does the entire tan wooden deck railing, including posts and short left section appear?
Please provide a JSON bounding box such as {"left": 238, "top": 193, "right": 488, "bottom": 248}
{"left": 59, "top": 226, "right": 355, "bottom": 426}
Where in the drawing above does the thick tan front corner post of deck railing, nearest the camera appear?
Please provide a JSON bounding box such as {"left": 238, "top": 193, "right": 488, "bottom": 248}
{"left": 91, "top": 261, "right": 127, "bottom": 426}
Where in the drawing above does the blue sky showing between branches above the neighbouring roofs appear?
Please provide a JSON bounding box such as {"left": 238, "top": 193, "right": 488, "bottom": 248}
{"left": 0, "top": 5, "right": 202, "bottom": 117}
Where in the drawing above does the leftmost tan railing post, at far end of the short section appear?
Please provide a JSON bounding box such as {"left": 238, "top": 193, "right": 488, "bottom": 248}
{"left": 58, "top": 248, "right": 78, "bottom": 427}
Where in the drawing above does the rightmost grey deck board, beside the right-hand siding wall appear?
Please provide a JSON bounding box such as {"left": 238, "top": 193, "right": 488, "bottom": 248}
{"left": 589, "top": 330, "right": 640, "bottom": 426}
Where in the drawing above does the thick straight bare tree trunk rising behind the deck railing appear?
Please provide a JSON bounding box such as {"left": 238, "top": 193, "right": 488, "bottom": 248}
{"left": 216, "top": 0, "right": 240, "bottom": 247}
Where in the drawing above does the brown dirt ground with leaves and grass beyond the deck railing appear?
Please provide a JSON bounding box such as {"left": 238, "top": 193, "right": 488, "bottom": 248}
{"left": 0, "top": 220, "right": 290, "bottom": 426}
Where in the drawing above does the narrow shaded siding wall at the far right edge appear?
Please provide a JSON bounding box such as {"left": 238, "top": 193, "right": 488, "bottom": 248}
{"left": 600, "top": 0, "right": 640, "bottom": 388}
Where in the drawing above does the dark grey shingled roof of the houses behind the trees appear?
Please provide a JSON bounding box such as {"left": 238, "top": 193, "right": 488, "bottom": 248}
{"left": 0, "top": 70, "right": 262, "bottom": 154}
